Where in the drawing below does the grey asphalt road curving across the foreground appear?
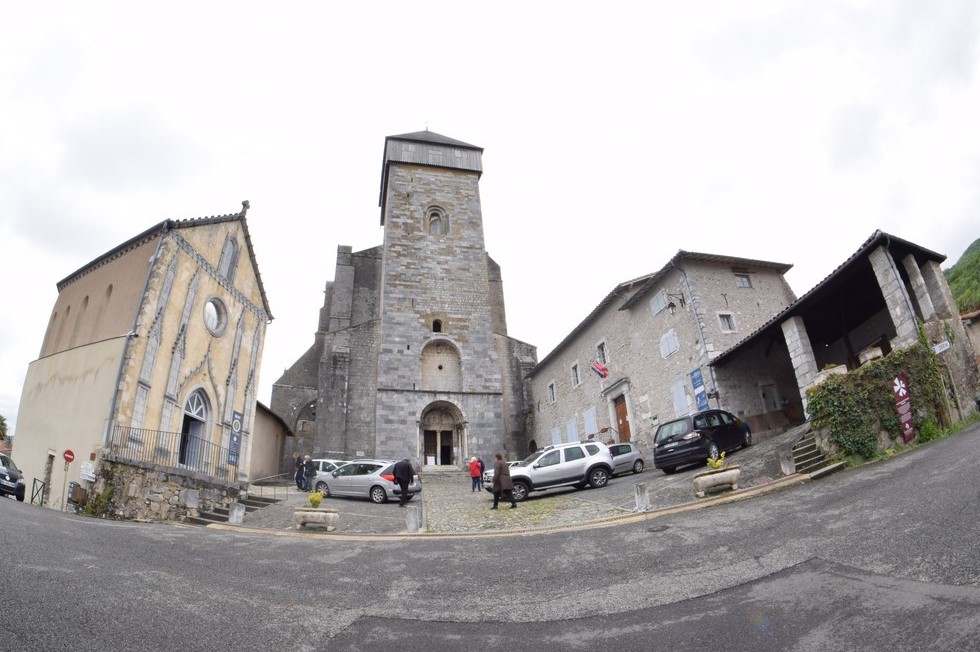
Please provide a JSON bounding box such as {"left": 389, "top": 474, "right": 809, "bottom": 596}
{"left": 0, "top": 425, "right": 980, "bottom": 652}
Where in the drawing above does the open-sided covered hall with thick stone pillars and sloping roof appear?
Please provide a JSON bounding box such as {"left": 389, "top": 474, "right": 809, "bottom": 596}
{"left": 710, "top": 230, "right": 980, "bottom": 422}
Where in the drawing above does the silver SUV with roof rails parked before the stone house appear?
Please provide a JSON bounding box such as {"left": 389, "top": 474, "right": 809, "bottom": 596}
{"left": 510, "top": 441, "right": 613, "bottom": 502}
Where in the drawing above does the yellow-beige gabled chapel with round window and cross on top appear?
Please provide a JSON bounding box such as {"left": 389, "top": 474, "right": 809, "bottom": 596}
{"left": 16, "top": 202, "right": 272, "bottom": 520}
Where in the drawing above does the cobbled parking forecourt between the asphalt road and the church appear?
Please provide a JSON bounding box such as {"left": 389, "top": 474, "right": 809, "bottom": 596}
{"left": 234, "top": 428, "right": 801, "bottom": 535}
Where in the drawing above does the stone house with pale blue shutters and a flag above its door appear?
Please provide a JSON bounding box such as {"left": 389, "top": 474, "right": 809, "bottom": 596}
{"left": 528, "top": 250, "right": 799, "bottom": 448}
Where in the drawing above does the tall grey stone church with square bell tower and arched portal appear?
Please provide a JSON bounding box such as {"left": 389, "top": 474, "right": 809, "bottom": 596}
{"left": 270, "top": 131, "right": 537, "bottom": 470}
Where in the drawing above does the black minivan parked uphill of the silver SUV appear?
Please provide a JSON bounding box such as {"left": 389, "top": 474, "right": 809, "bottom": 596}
{"left": 653, "top": 410, "right": 752, "bottom": 473}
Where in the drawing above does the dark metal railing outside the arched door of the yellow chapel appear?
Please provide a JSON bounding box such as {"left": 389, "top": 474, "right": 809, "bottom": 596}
{"left": 109, "top": 425, "right": 238, "bottom": 481}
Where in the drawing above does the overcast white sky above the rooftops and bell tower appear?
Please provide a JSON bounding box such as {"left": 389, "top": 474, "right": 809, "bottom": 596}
{"left": 0, "top": 0, "right": 980, "bottom": 434}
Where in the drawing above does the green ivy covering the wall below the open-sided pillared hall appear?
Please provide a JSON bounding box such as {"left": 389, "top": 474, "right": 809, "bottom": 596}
{"left": 807, "top": 334, "right": 944, "bottom": 459}
